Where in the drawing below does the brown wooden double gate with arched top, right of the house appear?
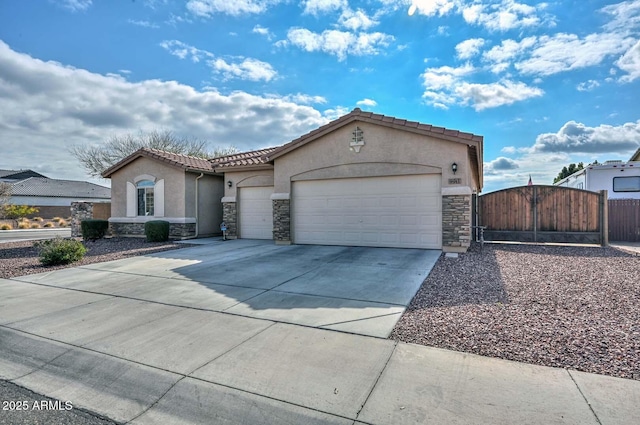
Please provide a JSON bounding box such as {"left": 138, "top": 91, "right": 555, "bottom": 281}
{"left": 478, "top": 185, "right": 608, "bottom": 245}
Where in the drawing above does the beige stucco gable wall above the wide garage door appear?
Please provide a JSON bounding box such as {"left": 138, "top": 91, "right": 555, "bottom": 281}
{"left": 274, "top": 122, "right": 474, "bottom": 193}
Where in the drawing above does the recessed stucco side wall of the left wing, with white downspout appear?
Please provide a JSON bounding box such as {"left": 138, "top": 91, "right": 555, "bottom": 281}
{"left": 184, "top": 173, "right": 224, "bottom": 237}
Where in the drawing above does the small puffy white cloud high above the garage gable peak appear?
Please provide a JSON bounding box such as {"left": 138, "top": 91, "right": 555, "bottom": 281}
{"left": 276, "top": 28, "right": 395, "bottom": 61}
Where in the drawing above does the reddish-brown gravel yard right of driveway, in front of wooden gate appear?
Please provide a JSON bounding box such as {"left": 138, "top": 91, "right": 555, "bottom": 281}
{"left": 391, "top": 244, "right": 640, "bottom": 380}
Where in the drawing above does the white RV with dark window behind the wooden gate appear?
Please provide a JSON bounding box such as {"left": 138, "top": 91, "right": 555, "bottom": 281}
{"left": 555, "top": 160, "right": 640, "bottom": 199}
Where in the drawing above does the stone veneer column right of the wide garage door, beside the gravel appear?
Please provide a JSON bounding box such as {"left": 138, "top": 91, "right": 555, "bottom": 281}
{"left": 442, "top": 194, "right": 471, "bottom": 252}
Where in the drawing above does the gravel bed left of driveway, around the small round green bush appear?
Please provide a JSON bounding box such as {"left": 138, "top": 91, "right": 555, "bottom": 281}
{"left": 0, "top": 238, "right": 190, "bottom": 279}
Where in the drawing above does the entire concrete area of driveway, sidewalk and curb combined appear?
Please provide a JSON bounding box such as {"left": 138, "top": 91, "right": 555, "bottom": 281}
{"left": 0, "top": 241, "right": 640, "bottom": 425}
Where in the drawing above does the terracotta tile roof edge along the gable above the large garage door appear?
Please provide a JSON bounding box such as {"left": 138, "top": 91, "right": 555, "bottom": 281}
{"left": 268, "top": 108, "right": 483, "bottom": 160}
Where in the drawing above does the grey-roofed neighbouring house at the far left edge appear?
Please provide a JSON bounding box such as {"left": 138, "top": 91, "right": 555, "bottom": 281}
{"left": 0, "top": 170, "right": 111, "bottom": 217}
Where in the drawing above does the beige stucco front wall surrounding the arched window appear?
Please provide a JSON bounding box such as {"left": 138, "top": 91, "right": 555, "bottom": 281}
{"left": 111, "top": 157, "right": 185, "bottom": 217}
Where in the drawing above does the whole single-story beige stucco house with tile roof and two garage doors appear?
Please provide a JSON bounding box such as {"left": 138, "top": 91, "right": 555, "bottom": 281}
{"left": 103, "top": 109, "right": 483, "bottom": 251}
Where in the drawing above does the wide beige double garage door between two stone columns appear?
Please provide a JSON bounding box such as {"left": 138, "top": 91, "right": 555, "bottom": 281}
{"left": 292, "top": 175, "right": 442, "bottom": 249}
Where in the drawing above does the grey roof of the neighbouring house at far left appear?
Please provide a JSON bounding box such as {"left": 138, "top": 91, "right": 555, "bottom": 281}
{"left": 11, "top": 177, "right": 111, "bottom": 199}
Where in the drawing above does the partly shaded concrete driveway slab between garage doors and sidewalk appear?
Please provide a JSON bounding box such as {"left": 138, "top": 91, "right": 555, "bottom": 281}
{"left": 12, "top": 240, "right": 440, "bottom": 337}
